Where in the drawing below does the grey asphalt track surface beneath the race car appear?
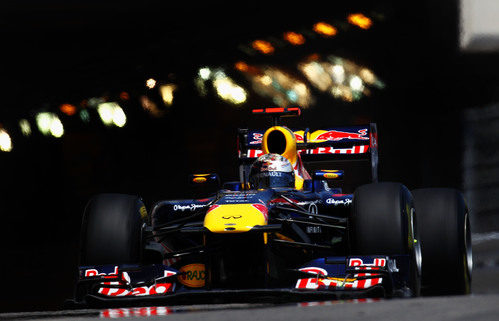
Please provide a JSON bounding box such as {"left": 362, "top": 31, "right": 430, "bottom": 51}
{"left": 0, "top": 233, "right": 499, "bottom": 321}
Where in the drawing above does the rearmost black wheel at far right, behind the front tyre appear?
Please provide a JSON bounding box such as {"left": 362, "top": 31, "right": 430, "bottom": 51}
{"left": 412, "top": 188, "right": 473, "bottom": 295}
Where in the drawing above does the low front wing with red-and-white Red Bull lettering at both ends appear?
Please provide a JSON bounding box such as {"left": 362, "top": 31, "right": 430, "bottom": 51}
{"left": 68, "top": 255, "right": 411, "bottom": 307}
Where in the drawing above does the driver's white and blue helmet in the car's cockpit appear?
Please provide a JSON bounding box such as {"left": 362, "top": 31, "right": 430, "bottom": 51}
{"left": 249, "top": 154, "right": 295, "bottom": 189}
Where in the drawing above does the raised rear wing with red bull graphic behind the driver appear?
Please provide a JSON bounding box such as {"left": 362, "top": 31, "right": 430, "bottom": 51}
{"left": 238, "top": 123, "right": 378, "bottom": 191}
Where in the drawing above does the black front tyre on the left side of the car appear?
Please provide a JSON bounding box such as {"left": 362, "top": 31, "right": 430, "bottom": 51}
{"left": 80, "top": 194, "right": 145, "bottom": 265}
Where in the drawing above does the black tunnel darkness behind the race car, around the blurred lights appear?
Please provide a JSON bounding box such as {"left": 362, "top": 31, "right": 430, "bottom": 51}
{"left": 0, "top": 0, "right": 499, "bottom": 311}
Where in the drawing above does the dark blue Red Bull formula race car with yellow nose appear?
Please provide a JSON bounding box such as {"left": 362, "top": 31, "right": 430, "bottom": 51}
{"left": 69, "top": 108, "right": 472, "bottom": 306}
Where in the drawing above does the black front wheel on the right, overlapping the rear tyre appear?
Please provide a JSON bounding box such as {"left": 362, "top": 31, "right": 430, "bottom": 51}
{"left": 349, "top": 183, "right": 421, "bottom": 296}
